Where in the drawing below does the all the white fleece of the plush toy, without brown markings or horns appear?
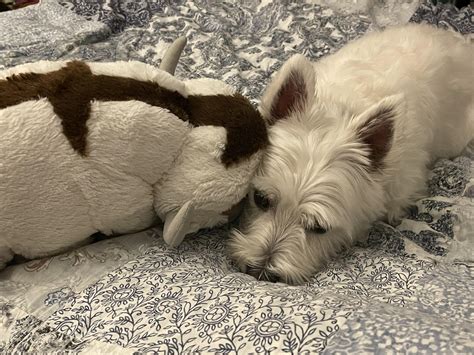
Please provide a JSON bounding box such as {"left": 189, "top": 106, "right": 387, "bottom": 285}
{"left": 0, "top": 61, "right": 260, "bottom": 269}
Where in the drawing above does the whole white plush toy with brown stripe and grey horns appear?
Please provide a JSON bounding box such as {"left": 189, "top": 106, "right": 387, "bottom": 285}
{"left": 0, "top": 38, "right": 268, "bottom": 267}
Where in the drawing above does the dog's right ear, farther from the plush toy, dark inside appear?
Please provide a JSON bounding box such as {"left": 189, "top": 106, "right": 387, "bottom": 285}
{"left": 355, "top": 95, "right": 404, "bottom": 169}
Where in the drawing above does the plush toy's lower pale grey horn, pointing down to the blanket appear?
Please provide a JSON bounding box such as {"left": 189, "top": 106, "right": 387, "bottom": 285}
{"left": 163, "top": 201, "right": 194, "bottom": 247}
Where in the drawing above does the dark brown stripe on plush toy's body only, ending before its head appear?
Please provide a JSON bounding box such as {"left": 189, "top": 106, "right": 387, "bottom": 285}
{"left": 0, "top": 61, "right": 188, "bottom": 155}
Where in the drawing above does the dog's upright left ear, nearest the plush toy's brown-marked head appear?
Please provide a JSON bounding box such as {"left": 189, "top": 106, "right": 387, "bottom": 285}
{"left": 260, "top": 54, "right": 315, "bottom": 125}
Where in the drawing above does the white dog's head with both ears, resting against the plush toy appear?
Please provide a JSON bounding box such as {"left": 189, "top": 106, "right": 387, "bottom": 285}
{"left": 229, "top": 55, "right": 399, "bottom": 284}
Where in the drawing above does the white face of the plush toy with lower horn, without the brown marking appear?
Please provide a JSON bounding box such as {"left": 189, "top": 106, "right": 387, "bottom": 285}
{"left": 155, "top": 126, "right": 262, "bottom": 246}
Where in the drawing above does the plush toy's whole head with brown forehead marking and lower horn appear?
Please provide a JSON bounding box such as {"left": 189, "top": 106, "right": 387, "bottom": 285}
{"left": 154, "top": 36, "right": 268, "bottom": 246}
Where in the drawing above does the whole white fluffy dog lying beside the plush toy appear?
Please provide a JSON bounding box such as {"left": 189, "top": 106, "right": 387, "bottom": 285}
{"left": 230, "top": 25, "right": 474, "bottom": 284}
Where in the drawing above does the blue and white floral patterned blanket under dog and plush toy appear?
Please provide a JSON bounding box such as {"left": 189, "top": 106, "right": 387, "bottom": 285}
{"left": 0, "top": 0, "right": 474, "bottom": 354}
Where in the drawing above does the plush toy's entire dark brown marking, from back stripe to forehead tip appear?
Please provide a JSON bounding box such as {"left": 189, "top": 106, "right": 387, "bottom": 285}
{"left": 0, "top": 61, "right": 268, "bottom": 165}
